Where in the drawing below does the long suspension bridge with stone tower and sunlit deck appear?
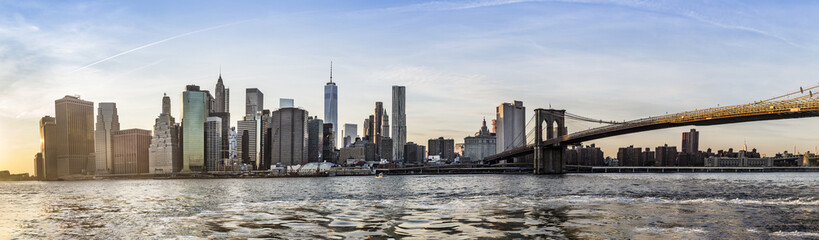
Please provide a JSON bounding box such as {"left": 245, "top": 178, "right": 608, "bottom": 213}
{"left": 483, "top": 85, "right": 819, "bottom": 174}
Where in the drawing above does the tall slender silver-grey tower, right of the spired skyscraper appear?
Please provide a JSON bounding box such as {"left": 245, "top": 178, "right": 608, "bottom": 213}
{"left": 391, "top": 86, "right": 407, "bottom": 161}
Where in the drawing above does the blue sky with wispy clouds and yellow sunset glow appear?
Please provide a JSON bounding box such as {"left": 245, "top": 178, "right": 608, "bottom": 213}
{"left": 0, "top": 0, "right": 819, "bottom": 173}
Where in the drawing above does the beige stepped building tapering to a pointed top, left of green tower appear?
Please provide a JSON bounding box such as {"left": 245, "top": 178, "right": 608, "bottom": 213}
{"left": 148, "top": 95, "right": 182, "bottom": 173}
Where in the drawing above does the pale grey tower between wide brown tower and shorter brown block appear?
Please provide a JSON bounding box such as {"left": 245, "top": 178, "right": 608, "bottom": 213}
{"left": 94, "top": 103, "right": 119, "bottom": 174}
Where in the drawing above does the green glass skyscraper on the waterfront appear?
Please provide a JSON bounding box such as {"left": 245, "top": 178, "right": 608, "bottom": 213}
{"left": 181, "top": 85, "right": 210, "bottom": 172}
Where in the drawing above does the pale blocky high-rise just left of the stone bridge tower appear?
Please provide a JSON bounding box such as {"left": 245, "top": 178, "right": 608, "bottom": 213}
{"left": 495, "top": 101, "right": 526, "bottom": 153}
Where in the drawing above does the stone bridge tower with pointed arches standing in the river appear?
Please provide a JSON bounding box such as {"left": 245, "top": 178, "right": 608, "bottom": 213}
{"left": 534, "top": 108, "right": 567, "bottom": 174}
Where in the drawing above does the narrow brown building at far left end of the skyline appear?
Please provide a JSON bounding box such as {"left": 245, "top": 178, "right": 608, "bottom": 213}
{"left": 40, "top": 116, "right": 59, "bottom": 181}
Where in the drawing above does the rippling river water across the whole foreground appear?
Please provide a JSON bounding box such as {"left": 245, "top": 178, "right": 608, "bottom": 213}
{"left": 0, "top": 173, "right": 819, "bottom": 239}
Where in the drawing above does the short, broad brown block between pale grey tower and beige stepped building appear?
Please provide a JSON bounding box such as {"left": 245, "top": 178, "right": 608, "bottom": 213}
{"left": 111, "top": 129, "right": 151, "bottom": 174}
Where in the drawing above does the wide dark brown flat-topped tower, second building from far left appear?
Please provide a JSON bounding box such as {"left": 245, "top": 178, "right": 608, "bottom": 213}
{"left": 54, "top": 96, "right": 96, "bottom": 177}
